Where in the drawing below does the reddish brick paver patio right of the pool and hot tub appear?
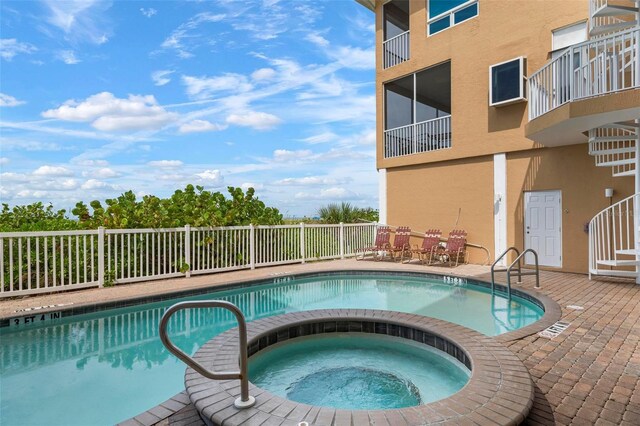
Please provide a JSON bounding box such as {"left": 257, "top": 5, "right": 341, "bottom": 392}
{"left": 483, "top": 272, "right": 640, "bottom": 425}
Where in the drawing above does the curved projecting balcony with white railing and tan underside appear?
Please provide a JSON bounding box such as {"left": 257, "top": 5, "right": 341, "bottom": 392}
{"left": 525, "top": 27, "right": 640, "bottom": 146}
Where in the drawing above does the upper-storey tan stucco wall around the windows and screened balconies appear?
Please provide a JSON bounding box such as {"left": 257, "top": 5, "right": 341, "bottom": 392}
{"left": 376, "top": 0, "right": 588, "bottom": 168}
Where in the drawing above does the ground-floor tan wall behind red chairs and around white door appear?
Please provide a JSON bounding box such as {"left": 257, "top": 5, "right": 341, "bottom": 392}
{"left": 387, "top": 144, "right": 633, "bottom": 273}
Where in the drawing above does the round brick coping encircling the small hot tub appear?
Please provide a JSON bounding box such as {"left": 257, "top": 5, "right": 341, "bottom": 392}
{"left": 180, "top": 309, "right": 534, "bottom": 426}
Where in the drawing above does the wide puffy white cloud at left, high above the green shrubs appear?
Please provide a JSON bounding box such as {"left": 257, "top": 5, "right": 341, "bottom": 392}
{"left": 42, "top": 92, "right": 178, "bottom": 131}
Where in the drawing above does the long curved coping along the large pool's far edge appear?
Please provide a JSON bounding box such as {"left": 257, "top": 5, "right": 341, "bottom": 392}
{"left": 0, "top": 268, "right": 562, "bottom": 342}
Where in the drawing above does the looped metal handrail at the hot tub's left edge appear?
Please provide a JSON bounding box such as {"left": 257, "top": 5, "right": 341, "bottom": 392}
{"left": 160, "top": 300, "right": 256, "bottom": 408}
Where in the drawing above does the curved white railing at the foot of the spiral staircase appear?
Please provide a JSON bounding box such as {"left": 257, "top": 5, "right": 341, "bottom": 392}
{"left": 589, "top": 193, "right": 640, "bottom": 276}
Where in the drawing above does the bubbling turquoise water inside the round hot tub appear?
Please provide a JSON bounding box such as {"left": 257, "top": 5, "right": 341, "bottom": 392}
{"left": 249, "top": 333, "right": 470, "bottom": 410}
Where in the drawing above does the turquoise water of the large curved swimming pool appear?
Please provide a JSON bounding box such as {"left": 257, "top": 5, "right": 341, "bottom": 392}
{"left": 0, "top": 275, "right": 543, "bottom": 426}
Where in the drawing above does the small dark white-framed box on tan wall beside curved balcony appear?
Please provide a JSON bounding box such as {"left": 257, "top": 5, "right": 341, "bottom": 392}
{"left": 489, "top": 56, "right": 527, "bottom": 107}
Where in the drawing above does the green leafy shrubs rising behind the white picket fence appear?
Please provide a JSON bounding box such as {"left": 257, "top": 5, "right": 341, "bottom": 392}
{"left": 0, "top": 184, "right": 378, "bottom": 232}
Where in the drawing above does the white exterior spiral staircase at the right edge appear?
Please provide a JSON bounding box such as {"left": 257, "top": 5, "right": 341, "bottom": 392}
{"left": 588, "top": 0, "right": 640, "bottom": 282}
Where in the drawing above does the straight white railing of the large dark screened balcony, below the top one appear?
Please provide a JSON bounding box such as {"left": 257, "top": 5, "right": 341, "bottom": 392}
{"left": 384, "top": 115, "right": 451, "bottom": 158}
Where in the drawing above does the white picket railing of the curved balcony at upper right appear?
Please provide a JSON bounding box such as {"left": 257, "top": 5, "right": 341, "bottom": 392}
{"left": 529, "top": 28, "right": 640, "bottom": 120}
